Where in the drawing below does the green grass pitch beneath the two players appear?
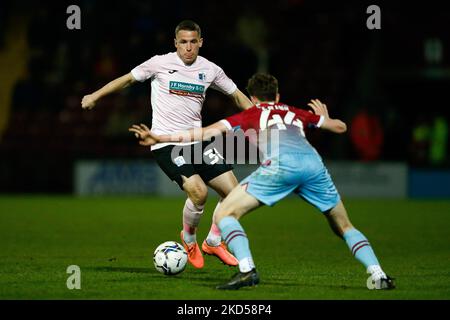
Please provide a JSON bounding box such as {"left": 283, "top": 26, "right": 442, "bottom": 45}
{"left": 0, "top": 196, "right": 450, "bottom": 300}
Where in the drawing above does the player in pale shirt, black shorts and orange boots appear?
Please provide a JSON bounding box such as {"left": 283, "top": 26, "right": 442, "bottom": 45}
{"left": 81, "top": 20, "right": 252, "bottom": 268}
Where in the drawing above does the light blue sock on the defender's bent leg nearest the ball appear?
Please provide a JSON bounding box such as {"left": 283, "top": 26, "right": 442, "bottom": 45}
{"left": 218, "top": 217, "right": 255, "bottom": 272}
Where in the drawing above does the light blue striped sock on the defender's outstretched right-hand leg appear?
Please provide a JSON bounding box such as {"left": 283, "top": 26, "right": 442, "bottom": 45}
{"left": 343, "top": 228, "right": 380, "bottom": 269}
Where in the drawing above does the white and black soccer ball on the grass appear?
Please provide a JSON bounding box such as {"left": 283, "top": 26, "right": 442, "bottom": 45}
{"left": 153, "top": 241, "right": 187, "bottom": 276}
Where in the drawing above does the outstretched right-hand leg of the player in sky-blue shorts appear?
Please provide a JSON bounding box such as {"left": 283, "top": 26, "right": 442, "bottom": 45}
{"left": 325, "top": 201, "right": 395, "bottom": 289}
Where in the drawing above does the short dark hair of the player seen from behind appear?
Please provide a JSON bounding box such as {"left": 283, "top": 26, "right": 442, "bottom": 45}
{"left": 247, "top": 73, "right": 278, "bottom": 101}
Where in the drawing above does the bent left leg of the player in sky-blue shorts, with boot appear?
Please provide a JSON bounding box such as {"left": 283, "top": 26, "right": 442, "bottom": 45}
{"left": 215, "top": 185, "right": 261, "bottom": 290}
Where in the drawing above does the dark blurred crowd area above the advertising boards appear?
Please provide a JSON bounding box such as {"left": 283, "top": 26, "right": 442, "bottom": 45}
{"left": 0, "top": 0, "right": 450, "bottom": 189}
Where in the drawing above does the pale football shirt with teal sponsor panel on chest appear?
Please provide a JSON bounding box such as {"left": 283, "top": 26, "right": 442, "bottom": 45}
{"left": 131, "top": 52, "right": 237, "bottom": 150}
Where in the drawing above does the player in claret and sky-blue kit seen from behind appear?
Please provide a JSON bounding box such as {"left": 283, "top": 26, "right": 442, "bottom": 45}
{"left": 129, "top": 74, "right": 395, "bottom": 289}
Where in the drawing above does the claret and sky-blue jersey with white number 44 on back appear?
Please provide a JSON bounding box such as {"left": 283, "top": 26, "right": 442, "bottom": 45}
{"left": 221, "top": 103, "right": 324, "bottom": 158}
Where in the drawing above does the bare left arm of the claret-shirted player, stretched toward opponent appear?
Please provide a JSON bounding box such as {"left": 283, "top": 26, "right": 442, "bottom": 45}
{"left": 128, "top": 122, "right": 228, "bottom": 146}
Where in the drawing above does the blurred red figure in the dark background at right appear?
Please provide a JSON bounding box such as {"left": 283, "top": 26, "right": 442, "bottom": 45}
{"left": 350, "top": 107, "right": 384, "bottom": 161}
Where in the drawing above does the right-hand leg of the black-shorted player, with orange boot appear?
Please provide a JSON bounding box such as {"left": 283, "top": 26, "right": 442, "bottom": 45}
{"left": 202, "top": 170, "right": 238, "bottom": 266}
